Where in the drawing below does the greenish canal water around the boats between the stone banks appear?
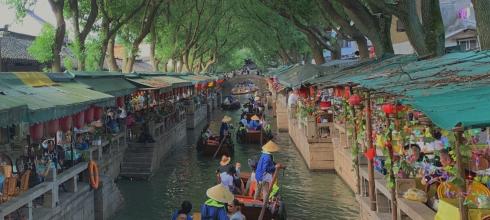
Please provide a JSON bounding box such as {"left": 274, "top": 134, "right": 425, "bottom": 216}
{"left": 113, "top": 93, "right": 359, "bottom": 220}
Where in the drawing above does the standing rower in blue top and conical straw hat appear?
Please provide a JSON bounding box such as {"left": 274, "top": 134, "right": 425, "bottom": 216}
{"left": 254, "top": 141, "right": 283, "bottom": 200}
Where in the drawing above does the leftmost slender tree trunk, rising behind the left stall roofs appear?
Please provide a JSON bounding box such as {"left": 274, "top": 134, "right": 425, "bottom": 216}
{"left": 49, "top": 0, "right": 66, "bottom": 72}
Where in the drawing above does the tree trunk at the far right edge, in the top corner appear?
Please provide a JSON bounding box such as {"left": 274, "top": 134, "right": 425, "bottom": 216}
{"left": 472, "top": 0, "right": 490, "bottom": 50}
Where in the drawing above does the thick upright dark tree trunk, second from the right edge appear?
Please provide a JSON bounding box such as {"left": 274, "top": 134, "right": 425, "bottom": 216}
{"left": 421, "top": 0, "right": 446, "bottom": 56}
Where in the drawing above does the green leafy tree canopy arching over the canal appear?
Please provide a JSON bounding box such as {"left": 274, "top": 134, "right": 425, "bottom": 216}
{"left": 3, "top": 0, "right": 488, "bottom": 72}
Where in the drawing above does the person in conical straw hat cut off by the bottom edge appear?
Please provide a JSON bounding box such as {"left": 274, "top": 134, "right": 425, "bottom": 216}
{"left": 201, "top": 184, "right": 235, "bottom": 220}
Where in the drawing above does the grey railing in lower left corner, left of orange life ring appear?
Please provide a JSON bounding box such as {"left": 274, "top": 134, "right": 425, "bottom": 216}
{"left": 0, "top": 162, "right": 87, "bottom": 220}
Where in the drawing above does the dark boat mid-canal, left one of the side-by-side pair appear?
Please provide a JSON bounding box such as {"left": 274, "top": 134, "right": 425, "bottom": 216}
{"left": 197, "top": 136, "right": 234, "bottom": 157}
